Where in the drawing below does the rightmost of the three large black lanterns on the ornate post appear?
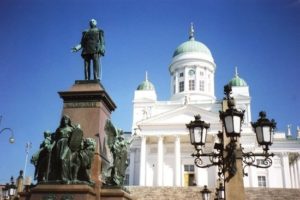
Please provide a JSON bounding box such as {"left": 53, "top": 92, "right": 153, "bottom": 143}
{"left": 252, "top": 111, "right": 276, "bottom": 150}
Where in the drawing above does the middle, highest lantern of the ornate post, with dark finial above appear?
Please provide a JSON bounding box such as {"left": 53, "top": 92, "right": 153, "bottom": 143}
{"left": 220, "top": 85, "right": 244, "bottom": 139}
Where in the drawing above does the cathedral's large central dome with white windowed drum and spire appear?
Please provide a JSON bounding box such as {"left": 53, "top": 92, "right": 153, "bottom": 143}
{"left": 169, "top": 24, "right": 216, "bottom": 102}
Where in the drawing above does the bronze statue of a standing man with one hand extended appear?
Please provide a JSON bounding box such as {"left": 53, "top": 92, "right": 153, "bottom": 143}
{"left": 72, "top": 19, "right": 105, "bottom": 80}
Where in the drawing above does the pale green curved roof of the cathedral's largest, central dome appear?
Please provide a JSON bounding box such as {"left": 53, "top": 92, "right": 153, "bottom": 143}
{"left": 173, "top": 38, "right": 212, "bottom": 57}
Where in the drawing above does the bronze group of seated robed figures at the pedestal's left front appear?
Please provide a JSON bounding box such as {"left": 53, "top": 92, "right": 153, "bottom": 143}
{"left": 31, "top": 115, "right": 96, "bottom": 184}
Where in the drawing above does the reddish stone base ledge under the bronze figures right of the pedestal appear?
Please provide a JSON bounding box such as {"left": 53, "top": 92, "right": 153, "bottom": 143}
{"left": 101, "top": 188, "right": 133, "bottom": 200}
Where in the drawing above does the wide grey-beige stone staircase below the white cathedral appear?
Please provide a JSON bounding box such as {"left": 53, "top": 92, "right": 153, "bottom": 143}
{"left": 126, "top": 186, "right": 300, "bottom": 200}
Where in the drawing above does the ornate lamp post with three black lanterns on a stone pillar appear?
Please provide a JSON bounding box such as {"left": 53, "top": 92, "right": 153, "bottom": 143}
{"left": 186, "top": 85, "right": 276, "bottom": 200}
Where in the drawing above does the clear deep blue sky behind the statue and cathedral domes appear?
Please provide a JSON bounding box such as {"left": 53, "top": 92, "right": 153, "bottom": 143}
{"left": 0, "top": 0, "right": 300, "bottom": 183}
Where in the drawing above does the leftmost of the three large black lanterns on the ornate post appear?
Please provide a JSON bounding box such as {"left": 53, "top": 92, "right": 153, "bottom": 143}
{"left": 186, "top": 115, "right": 210, "bottom": 149}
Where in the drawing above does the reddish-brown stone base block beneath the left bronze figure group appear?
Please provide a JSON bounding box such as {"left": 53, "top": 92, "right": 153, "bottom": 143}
{"left": 20, "top": 184, "right": 97, "bottom": 200}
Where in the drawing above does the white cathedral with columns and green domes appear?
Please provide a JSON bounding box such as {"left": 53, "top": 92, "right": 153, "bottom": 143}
{"left": 126, "top": 25, "right": 300, "bottom": 188}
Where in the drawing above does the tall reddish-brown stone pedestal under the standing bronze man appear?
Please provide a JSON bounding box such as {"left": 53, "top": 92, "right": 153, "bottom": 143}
{"left": 59, "top": 80, "right": 116, "bottom": 199}
